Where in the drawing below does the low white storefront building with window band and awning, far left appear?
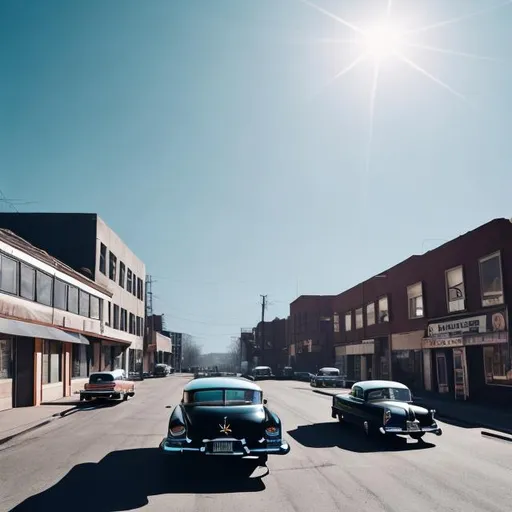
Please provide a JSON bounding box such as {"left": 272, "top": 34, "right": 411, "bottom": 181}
{"left": 0, "top": 229, "right": 113, "bottom": 410}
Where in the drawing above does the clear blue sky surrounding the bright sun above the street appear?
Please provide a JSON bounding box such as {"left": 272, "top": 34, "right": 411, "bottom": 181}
{"left": 0, "top": 0, "right": 512, "bottom": 351}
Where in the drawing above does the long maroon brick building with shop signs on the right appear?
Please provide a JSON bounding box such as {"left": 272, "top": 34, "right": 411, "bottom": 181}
{"left": 330, "top": 219, "right": 512, "bottom": 402}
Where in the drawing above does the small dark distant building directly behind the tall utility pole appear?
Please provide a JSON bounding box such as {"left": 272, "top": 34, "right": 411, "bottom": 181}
{"left": 255, "top": 318, "right": 288, "bottom": 373}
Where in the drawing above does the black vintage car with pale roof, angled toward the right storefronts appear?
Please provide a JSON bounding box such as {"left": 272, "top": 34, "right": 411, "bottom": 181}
{"left": 331, "top": 380, "right": 442, "bottom": 439}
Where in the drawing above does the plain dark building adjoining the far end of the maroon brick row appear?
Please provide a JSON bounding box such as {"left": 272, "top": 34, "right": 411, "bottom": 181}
{"left": 288, "top": 295, "right": 339, "bottom": 373}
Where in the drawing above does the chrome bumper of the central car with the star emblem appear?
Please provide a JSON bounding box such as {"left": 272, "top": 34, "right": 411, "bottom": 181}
{"left": 160, "top": 437, "right": 290, "bottom": 457}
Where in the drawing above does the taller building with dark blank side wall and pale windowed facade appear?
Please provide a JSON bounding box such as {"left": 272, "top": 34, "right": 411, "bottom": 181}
{"left": 0, "top": 213, "right": 146, "bottom": 371}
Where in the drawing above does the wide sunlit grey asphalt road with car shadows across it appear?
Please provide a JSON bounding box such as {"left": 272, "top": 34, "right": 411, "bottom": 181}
{"left": 0, "top": 376, "right": 512, "bottom": 512}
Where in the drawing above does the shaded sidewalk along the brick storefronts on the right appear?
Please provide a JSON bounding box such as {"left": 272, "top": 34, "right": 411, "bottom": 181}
{"left": 313, "top": 389, "right": 512, "bottom": 435}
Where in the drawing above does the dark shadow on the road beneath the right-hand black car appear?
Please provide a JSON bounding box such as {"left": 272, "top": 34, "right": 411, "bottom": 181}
{"left": 288, "top": 421, "right": 435, "bottom": 453}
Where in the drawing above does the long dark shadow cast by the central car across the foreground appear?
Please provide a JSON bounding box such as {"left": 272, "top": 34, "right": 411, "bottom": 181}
{"left": 11, "top": 448, "right": 268, "bottom": 512}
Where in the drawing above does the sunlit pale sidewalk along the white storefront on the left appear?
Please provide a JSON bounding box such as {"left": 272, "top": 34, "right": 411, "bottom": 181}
{"left": 0, "top": 395, "right": 81, "bottom": 445}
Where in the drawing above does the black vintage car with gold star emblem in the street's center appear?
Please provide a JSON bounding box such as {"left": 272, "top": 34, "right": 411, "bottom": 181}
{"left": 160, "top": 377, "right": 290, "bottom": 465}
